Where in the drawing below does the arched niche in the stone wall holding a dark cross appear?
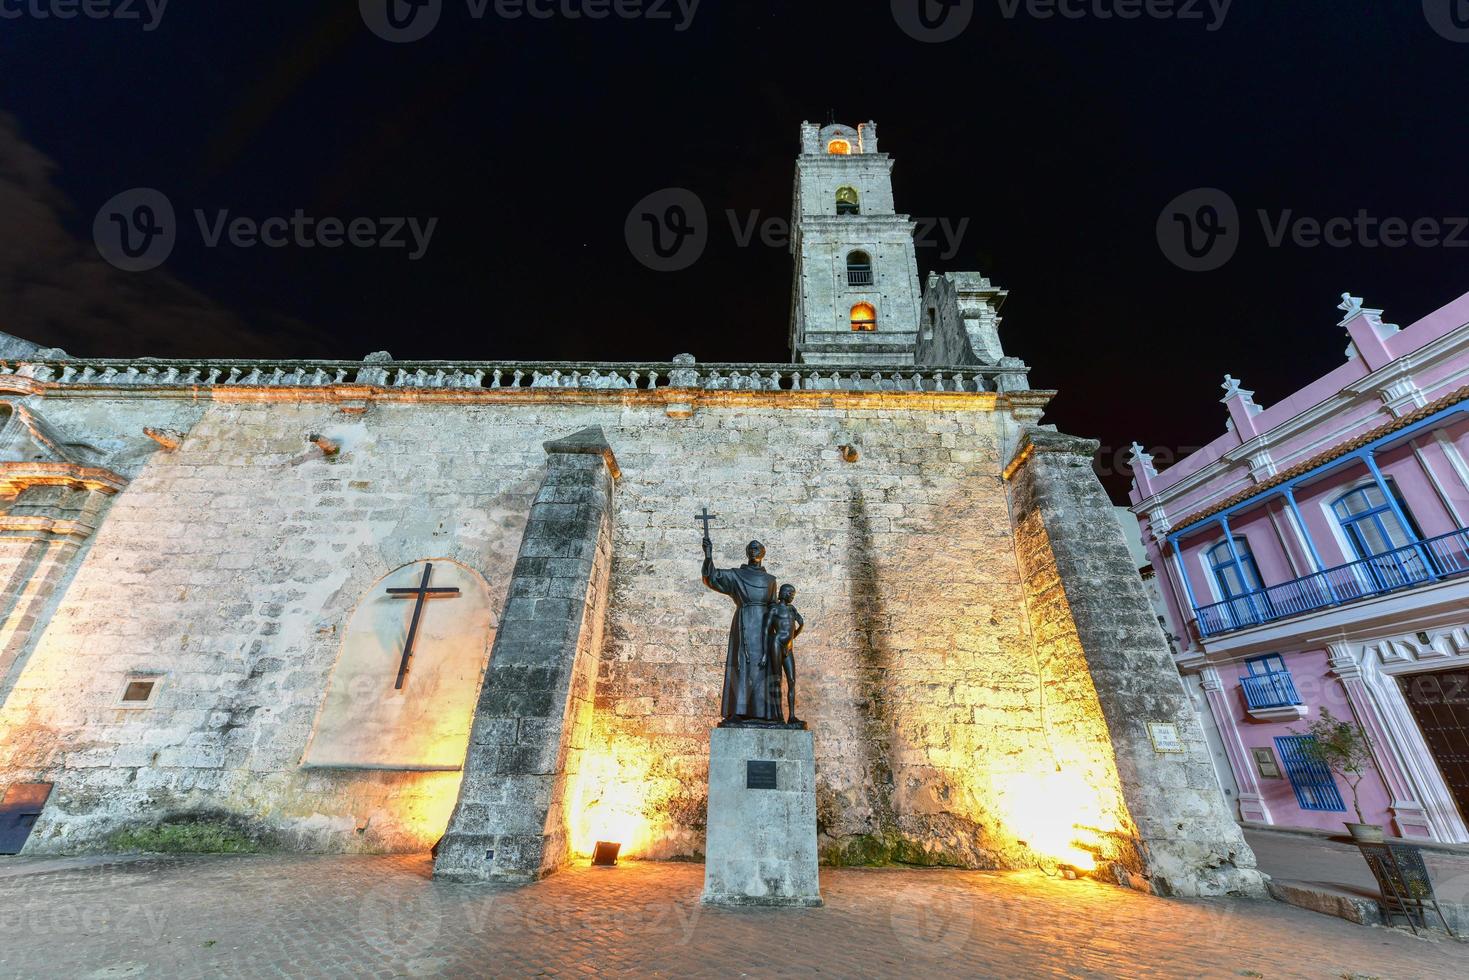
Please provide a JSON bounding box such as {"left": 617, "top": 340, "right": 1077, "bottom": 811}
{"left": 301, "top": 558, "right": 495, "bottom": 771}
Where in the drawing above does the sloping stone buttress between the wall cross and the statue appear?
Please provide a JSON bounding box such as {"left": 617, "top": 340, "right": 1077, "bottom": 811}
{"left": 433, "top": 426, "right": 618, "bottom": 880}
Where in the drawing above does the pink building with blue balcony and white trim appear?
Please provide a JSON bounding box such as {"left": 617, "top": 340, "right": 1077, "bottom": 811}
{"left": 1131, "top": 294, "right": 1469, "bottom": 842}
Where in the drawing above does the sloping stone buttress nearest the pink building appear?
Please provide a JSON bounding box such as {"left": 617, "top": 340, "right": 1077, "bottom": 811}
{"left": 1009, "top": 430, "right": 1262, "bottom": 895}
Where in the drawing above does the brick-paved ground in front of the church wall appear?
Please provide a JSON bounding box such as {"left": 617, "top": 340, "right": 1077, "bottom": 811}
{"left": 0, "top": 855, "right": 1469, "bottom": 980}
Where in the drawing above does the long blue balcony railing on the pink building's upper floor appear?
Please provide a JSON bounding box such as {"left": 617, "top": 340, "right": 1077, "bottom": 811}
{"left": 1194, "top": 527, "right": 1469, "bottom": 638}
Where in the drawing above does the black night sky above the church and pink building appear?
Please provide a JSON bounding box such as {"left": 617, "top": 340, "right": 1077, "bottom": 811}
{"left": 0, "top": 0, "right": 1469, "bottom": 500}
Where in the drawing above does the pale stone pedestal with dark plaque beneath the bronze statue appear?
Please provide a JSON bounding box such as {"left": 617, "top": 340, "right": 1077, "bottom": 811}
{"left": 704, "top": 729, "right": 821, "bottom": 905}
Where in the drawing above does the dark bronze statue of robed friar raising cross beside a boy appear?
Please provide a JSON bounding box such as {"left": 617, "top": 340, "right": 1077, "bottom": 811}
{"left": 696, "top": 508, "right": 806, "bottom": 729}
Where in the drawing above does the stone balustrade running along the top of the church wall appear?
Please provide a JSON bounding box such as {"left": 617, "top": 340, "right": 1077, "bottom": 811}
{"left": 0, "top": 356, "right": 1030, "bottom": 394}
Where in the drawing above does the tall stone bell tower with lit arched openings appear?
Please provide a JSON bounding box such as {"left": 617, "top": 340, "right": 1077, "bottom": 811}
{"left": 790, "top": 122, "right": 921, "bottom": 364}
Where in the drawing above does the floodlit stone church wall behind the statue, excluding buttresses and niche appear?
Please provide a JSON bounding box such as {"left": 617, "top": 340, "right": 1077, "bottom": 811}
{"left": 0, "top": 392, "right": 1087, "bottom": 864}
